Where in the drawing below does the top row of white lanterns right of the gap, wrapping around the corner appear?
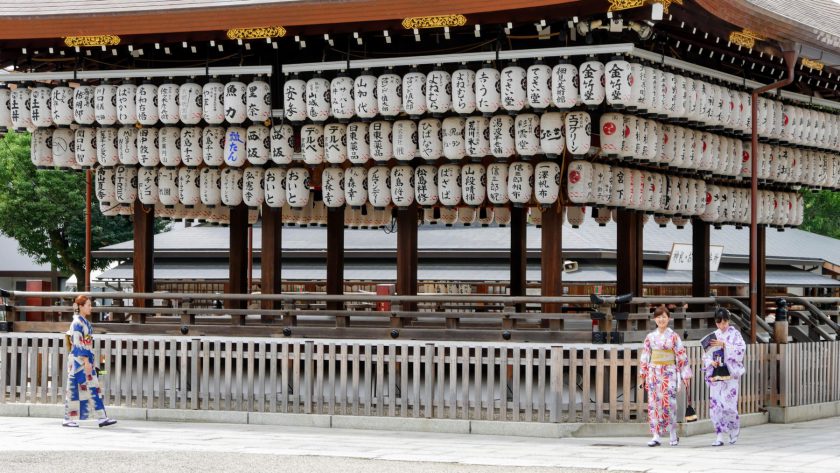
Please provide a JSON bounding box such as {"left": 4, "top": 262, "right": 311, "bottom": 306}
{"left": 283, "top": 58, "right": 840, "bottom": 151}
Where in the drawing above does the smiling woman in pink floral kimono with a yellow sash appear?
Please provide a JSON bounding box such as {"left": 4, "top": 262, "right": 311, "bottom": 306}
{"left": 639, "top": 306, "right": 692, "bottom": 447}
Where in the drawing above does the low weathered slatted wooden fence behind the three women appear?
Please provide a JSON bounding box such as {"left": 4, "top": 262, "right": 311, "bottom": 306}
{"left": 0, "top": 333, "right": 840, "bottom": 422}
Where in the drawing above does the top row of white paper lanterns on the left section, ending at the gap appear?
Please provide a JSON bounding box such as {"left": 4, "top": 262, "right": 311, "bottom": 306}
{"left": 0, "top": 78, "right": 271, "bottom": 130}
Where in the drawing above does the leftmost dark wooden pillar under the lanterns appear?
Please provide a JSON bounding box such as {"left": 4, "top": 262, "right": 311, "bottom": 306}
{"left": 131, "top": 201, "right": 155, "bottom": 323}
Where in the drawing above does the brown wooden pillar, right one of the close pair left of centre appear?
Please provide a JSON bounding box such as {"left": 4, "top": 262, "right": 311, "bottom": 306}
{"left": 260, "top": 203, "right": 283, "bottom": 322}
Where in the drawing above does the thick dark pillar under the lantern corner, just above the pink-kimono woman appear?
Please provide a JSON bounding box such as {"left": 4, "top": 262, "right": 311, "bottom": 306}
{"left": 615, "top": 209, "right": 644, "bottom": 312}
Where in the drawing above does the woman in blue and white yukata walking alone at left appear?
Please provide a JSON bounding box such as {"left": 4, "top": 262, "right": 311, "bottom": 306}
{"left": 61, "top": 295, "right": 117, "bottom": 427}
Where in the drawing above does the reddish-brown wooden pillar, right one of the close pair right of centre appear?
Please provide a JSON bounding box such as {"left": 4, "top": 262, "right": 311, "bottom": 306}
{"left": 540, "top": 202, "right": 563, "bottom": 330}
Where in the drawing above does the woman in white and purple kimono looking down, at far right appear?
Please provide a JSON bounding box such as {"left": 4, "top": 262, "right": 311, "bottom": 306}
{"left": 703, "top": 308, "right": 747, "bottom": 447}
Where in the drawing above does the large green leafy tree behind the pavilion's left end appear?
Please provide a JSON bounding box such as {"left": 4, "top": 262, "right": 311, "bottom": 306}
{"left": 0, "top": 132, "right": 164, "bottom": 281}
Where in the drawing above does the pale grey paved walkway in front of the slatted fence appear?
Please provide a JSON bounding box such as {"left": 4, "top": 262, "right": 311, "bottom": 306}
{"left": 0, "top": 417, "right": 840, "bottom": 473}
